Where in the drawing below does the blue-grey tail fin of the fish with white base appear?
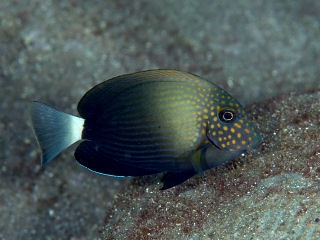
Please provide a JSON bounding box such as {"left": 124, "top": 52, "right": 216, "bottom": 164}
{"left": 31, "top": 101, "right": 84, "bottom": 166}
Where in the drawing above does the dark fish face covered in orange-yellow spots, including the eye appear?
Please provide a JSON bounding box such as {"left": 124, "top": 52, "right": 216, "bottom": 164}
{"left": 207, "top": 90, "right": 261, "bottom": 151}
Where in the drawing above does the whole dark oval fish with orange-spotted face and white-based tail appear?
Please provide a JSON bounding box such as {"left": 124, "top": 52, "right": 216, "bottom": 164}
{"left": 31, "top": 69, "right": 262, "bottom": 190}
